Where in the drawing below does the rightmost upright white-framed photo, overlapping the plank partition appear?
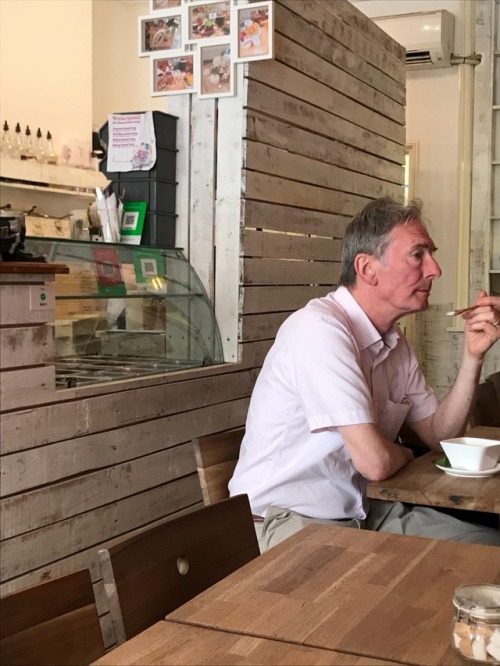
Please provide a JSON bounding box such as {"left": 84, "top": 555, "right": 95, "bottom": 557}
{"left": 233, "top": 0, "right": 274, "bottom": 62}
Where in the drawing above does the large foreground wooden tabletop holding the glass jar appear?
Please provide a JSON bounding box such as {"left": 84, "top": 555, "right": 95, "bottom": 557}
{"left": 167, "top": 524, "right": 500, "bottom": 666}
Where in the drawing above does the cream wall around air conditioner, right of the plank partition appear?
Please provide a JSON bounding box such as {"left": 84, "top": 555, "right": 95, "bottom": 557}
{"left": 352, "top": 0, "right": 460, "bottom": 304}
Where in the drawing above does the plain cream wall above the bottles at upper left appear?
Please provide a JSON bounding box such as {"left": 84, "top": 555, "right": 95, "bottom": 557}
{"left": 0, "top": 0, "right": 161, "bottom": 154}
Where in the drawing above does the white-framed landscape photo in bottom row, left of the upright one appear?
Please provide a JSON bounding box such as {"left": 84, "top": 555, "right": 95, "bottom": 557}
{"left": 151, "top": 51, "right": 197, "bottom": 97}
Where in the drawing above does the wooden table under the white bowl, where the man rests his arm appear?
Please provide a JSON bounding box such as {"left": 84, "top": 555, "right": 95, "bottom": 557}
{"left": 367, "top": 427, "right": 500, "bottom": 514}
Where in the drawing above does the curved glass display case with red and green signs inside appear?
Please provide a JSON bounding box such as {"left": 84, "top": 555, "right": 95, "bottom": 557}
{"left": 26, "top": 237, "right": 223, "bottom": 388}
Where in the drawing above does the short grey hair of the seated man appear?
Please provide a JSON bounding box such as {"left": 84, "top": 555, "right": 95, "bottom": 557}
{"left": 339, "top": 197, "right": 425, "bottom": 287}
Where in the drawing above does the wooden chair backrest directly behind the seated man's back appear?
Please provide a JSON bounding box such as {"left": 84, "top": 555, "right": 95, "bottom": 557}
{"left": 193, "top": 428, "right": 245, "bottom": 505}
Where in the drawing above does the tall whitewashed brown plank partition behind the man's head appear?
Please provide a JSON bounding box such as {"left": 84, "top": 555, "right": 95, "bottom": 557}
{"left": 241, "top": 0, "right": 405, "bottom": 345}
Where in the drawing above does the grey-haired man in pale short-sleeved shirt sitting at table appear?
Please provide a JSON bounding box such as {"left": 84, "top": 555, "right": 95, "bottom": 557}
{"left": 229, "top": 197, "right": 500, "bottom": 550}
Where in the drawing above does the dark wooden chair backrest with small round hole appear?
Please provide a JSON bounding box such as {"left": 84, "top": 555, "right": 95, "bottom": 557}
{"left": 98, "top": 495, "right": 260, "bottom": 644}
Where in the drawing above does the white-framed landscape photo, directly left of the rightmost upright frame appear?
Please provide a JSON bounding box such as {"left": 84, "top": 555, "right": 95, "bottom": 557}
{"left": 185, "top": 0, "right": 231, "bottom": 43}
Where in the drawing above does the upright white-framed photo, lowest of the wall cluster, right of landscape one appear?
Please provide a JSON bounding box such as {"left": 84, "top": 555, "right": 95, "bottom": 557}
{"left": 198, "top": 42, "right": 235, "bottom": 99}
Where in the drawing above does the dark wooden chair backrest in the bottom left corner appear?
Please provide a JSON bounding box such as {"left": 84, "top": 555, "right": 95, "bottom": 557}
{"left": 0, "top": 569, "right": 104, "bottom": 666}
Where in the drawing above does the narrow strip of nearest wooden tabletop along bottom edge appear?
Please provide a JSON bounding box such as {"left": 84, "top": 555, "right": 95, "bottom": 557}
{"left": 94, "top": 621, "right": 398, "bottom": 666}
